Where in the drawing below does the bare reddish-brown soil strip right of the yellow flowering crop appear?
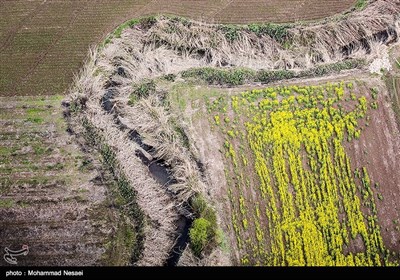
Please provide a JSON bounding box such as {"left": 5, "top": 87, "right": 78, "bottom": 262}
{"left": 346, "top": 80, "right": 400, "bottom": 252}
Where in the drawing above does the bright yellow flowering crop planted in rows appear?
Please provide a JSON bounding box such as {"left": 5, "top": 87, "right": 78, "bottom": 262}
{"left": 214, "top": 82, "right": 393, "bottom": 266}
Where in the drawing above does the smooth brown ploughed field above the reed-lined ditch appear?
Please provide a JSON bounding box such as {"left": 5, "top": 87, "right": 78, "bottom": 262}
{"left": 0, "top": 0, "right": 355, "bottom": 96}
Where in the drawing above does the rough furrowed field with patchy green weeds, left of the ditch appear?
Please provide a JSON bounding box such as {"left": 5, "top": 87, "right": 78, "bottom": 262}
{"left": 0, "top": 96, "right": 134, "bottom": 266}
